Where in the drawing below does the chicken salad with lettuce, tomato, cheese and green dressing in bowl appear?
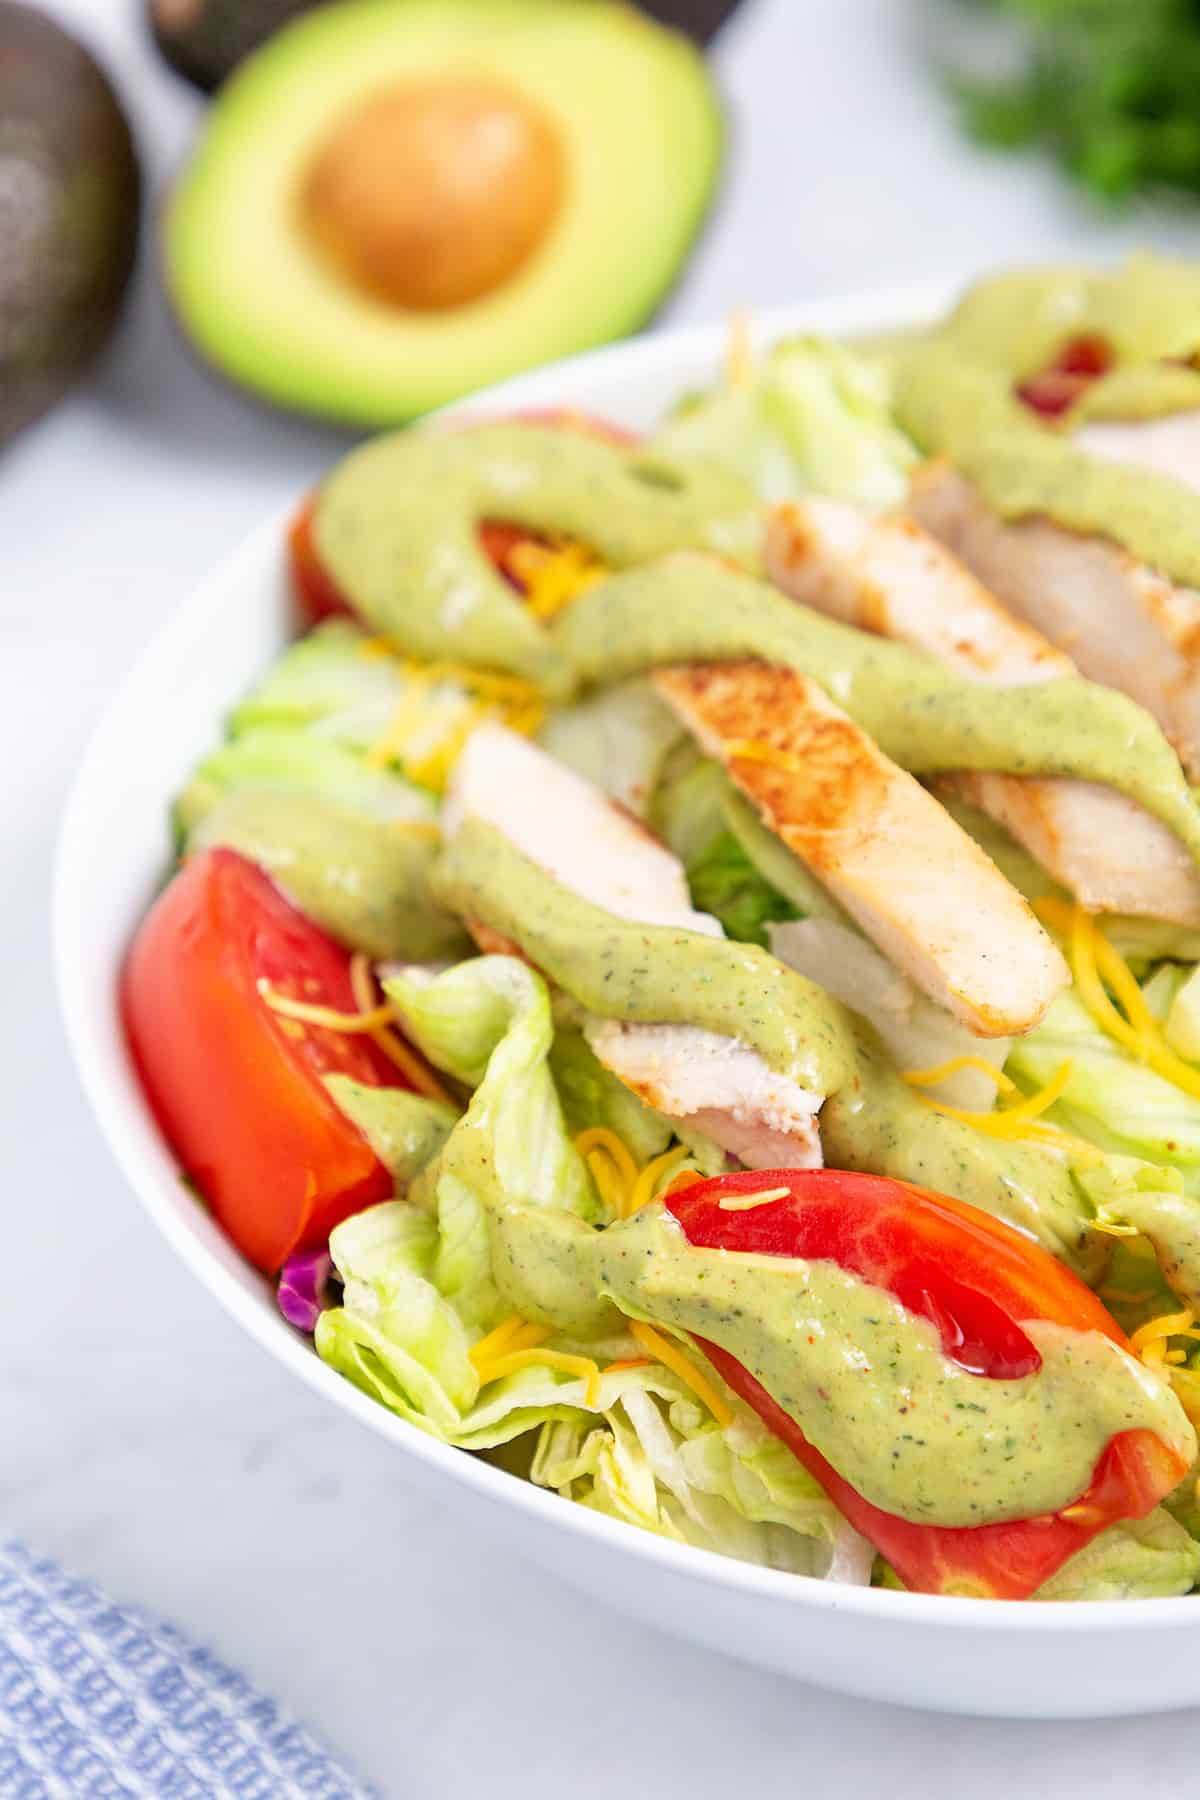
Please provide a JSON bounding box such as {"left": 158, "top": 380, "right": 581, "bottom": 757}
{"left": 121, "top": 257, "right": 1200, "bottom": 1600}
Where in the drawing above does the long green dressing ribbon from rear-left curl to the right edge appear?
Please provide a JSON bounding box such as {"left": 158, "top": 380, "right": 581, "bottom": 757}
{"left": 317, "top": 423, "right": 1200, "bottom": 859}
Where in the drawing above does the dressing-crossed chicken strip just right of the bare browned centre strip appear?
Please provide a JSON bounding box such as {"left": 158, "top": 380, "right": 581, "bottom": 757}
{"left": 766, "top": 499, "right": 1200, "bottom": 925}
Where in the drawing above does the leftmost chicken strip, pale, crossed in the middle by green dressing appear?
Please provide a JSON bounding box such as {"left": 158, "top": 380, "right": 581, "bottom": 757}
{"left": 443, "top": 725, "right": 824, "bottom": 1168}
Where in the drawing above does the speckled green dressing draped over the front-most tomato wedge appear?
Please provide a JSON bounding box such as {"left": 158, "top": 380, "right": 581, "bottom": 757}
{"left": 596, "top": 1202, "right": 1195, "bottom": 1526}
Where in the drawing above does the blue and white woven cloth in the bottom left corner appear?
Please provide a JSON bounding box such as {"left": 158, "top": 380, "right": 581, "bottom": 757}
{"left": 0, "top": 1541, "right": 372, "bottom": 1800}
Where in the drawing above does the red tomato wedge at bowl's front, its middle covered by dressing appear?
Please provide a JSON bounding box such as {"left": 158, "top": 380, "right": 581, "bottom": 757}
{"left": 666, "top": 1168, "right": 1187, "bottom": 1600}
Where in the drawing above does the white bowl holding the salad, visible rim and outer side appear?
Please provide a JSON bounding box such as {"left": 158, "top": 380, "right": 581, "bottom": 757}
{"left": 54, "top": 286, "right": 1200, "bottom": 1719}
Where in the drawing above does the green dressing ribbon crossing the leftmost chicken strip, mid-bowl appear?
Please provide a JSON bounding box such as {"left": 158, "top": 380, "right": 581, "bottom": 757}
{"left": 434, "top": 819, "right": 1105, "bottom": 1274}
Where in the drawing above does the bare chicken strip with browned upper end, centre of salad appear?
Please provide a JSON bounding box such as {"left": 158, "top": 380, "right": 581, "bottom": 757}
{"left": 655, "top": 662, "right": 1069, "bottom": 1037}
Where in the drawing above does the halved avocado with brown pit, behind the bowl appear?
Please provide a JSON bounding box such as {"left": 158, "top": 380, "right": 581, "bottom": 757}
{"left": 166, "top": 0, "right": 721, "bottom": 425}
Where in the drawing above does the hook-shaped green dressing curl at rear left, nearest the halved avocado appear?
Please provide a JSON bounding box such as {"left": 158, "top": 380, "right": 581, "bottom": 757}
{"left": 315, "top": 425, "right": 761, "bottom": 693}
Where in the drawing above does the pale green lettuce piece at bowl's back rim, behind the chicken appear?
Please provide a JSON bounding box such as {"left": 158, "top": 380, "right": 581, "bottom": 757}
{"left": 655, "top": 337, "right": 916, "bottom": 508}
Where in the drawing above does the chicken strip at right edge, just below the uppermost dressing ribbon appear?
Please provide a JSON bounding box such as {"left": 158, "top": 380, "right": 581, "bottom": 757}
{"left": 909, "top": 457, "right": 1200, "bottom": 781}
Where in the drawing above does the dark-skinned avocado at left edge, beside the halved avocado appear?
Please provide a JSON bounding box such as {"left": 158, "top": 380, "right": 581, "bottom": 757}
{"left": 0, "top": 0, "right": 140, "bottom": 445}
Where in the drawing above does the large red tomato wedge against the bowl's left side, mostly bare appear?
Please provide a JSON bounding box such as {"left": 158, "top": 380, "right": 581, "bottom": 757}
{"left": 121, "top": 850, "right": 407, "bottom": 1273}
